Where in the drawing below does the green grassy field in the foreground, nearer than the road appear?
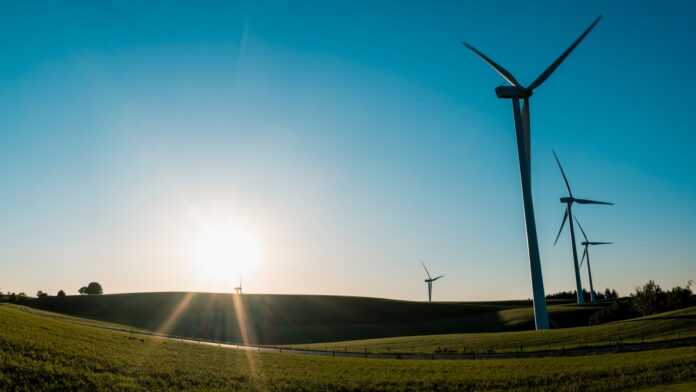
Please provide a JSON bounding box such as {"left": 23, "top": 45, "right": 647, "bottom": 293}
{"left": 0, "top": 305, "right": 696, "bottom": 391}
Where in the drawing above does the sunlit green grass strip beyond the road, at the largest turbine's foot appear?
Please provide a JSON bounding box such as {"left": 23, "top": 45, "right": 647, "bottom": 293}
{"left": 295, "top": 306, "right": 696, "bottom": 354}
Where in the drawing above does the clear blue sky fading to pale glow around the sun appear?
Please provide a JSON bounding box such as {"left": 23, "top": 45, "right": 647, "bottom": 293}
{"left": 0, "top": 1, "right": 696, "bottom": 300}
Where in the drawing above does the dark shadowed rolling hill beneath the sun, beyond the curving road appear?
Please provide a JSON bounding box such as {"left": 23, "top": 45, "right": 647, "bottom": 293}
{"left": 19, "top": 292, "right": 584, "bottom": 344}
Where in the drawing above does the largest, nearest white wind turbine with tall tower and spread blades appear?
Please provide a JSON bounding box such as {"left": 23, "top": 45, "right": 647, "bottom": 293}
{"left": 463, "top": 15, "right": 602, "bottom": 330}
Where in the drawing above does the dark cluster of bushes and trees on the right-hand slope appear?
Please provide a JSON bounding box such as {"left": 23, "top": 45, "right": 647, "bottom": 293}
{"left": 590, "top": 280, "right": 696, "bottom": 325}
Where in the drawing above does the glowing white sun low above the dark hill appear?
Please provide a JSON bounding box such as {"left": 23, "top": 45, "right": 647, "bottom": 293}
{"left": 188, "top": 217, "right": 261, "bottom": 286}
